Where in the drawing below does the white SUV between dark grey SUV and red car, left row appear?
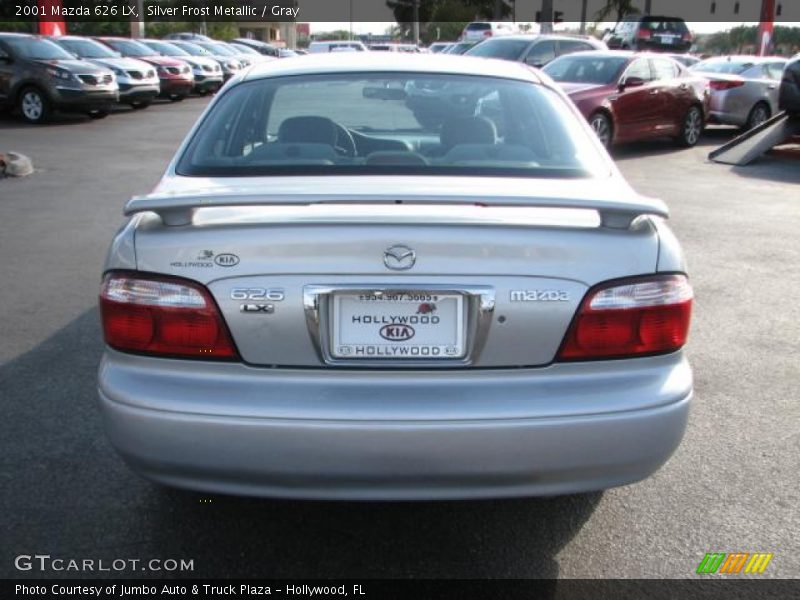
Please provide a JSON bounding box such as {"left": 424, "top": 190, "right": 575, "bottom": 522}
{"left": 50, "top": 35, "right": 161, "bottom": 109}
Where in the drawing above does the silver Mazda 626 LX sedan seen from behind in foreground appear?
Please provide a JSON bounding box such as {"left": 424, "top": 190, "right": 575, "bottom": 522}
{"left": 99, "top": 53, "right": 692, "bottom": 499}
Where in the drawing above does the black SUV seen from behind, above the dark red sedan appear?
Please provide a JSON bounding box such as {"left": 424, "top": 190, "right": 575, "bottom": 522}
{"left": 603, "top": 16, "right": 693, "bottom": 54}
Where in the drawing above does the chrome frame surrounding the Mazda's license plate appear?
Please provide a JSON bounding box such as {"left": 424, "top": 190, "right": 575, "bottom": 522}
{"left": 303, "top": 283, "right": 495, "bottom": 368}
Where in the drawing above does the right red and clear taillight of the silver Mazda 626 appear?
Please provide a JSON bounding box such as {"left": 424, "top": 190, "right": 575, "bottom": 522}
{"left": 558, "top": 275, "right": 694, "bottom": 360}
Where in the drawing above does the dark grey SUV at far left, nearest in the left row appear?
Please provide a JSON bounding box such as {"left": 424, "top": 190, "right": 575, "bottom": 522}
{"left": 0, "top": 33, "right": 119, "bottom": 123}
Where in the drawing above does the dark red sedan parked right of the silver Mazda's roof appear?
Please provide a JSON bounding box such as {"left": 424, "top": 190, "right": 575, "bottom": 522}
{"left": 544, "top": 51, "right": 711, "bottom": 148}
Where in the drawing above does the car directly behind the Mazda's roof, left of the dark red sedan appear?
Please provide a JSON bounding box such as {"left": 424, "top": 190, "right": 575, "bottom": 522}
{"left": 464, "top": 35, "right": 607, "bottom": 67}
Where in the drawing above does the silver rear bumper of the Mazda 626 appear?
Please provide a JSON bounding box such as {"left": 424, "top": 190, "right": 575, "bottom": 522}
{"left": 99, "top": 350, "right": 692, "bottom": 500}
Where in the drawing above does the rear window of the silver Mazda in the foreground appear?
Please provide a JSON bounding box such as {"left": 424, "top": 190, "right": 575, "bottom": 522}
{"left": 177, "top": 73, "right": 608, "bottom": 177}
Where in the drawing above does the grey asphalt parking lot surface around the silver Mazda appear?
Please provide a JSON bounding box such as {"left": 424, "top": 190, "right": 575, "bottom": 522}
{"left": 0, "top": 99, "right": 800, "bottom": 578}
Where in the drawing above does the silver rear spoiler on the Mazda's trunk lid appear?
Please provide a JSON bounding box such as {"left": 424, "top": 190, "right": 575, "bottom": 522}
{"left": 124, "top": 192, "right": 669, "bottom": 229}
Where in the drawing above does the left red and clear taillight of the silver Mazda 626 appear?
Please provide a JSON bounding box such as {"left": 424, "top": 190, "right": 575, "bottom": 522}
{"left": 100, "top": 272, "right": 238, "bottom": 360}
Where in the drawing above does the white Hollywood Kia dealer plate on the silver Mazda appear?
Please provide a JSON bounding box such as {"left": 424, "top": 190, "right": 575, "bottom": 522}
{"left": 331, "top": 291, "right": 466, "bottom": 359}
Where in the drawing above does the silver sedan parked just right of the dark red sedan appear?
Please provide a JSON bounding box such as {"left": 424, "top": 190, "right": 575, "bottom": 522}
{"left": 692, "top": 56, "right": 788, "bottom": 130}
